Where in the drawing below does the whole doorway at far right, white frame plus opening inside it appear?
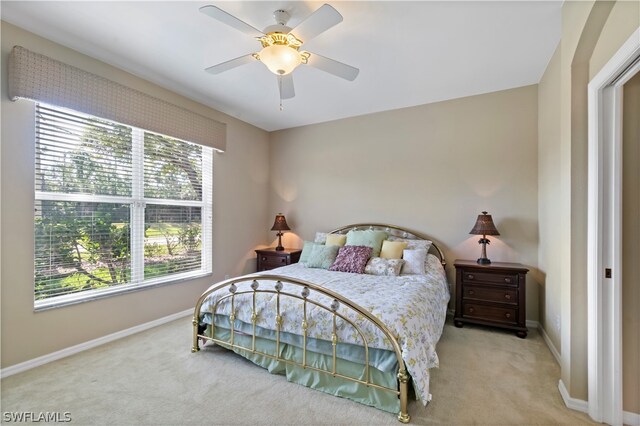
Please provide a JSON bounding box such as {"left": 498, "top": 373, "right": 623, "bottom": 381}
{"left": 588, "top": 29, "right": 640, "bottom": 425}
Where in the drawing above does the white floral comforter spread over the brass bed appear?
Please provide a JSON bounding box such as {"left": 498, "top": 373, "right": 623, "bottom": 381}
{"left": 201, "top": 255, "right": 449, "bottom": 405}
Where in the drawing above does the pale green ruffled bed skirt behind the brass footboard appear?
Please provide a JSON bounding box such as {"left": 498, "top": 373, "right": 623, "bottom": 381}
{"left": 205, "top": 325, "right": 400, "bottom": 413}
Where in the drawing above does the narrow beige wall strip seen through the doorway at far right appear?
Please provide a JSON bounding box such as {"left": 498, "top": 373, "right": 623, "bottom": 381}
{"left": 622, "top": 73, "right": 640, "bottom": 413}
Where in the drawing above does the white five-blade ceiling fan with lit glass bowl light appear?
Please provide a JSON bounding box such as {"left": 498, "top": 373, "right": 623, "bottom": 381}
{"left": 200, "top": 4, "right": 360, "bottom": 109}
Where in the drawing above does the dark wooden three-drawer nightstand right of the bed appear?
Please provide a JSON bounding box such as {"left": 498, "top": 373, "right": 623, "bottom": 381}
{"left": 453, "top": 259, "right": 529, "bottom": 339}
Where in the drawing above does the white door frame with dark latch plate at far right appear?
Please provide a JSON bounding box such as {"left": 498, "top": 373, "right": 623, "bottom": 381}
{"left": 587, "top": 28, "right": 640, "bottom": 425}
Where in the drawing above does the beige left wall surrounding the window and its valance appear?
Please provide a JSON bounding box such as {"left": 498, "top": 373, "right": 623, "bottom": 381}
{"left": 0, "top": 22, "right": 269, "bottom": 368}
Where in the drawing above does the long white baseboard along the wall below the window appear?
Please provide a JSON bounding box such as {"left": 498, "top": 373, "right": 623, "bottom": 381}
{"left": 0, "top": 309, "right": 193, "bottom": 379}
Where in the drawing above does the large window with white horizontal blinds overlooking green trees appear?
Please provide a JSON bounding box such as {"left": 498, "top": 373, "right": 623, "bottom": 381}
{"left": 34, "top": 104, "right": 213, "bottom": 309}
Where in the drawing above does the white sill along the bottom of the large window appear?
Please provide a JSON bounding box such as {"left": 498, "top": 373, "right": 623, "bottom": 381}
{"left": 33, "top": 271, "right": 213, "bottom": 312}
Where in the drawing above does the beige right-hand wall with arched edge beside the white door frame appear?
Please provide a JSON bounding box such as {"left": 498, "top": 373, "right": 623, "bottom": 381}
{"left": 539, "top": 1, "right": 640, "bottom": 400}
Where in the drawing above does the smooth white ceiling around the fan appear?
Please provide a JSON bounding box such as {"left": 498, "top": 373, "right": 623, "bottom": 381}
{"left": 1, "top": 0, "right": 562, "bottom": 131}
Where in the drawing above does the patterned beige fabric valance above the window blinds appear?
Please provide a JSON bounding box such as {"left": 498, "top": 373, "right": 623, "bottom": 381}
{"left": 8, "top": 46, "right": 227, "bottom": 151}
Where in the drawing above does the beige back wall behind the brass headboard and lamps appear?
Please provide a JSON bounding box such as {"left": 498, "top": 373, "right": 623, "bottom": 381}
{"left": 269, "top": 86, "right": 540, "bottom": 320}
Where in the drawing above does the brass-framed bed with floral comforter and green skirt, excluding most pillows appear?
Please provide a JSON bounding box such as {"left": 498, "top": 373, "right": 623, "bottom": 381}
{"left": 192, "top": 224, "right": 449, "bottom": 423}
